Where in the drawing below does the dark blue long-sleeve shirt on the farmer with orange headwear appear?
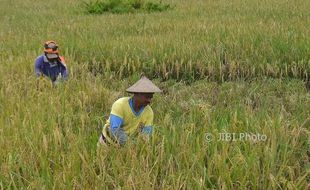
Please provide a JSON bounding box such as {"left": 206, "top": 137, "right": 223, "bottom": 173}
{"left": 34, "top": 54, "right": 68, "bottom": 82}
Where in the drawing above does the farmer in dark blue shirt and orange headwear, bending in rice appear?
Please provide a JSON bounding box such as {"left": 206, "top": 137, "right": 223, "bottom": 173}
{"left": 34, "top": 41, "right": 68, "bottom": 84}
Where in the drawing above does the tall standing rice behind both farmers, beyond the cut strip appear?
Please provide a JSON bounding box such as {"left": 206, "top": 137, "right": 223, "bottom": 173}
{"left": 1, "top": 0, "right": 310, "bottom": 81}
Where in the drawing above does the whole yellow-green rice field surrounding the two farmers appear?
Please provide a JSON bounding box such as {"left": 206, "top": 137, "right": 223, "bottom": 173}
{"left": 0, "top": 0, "right": 310, "bottom": 189}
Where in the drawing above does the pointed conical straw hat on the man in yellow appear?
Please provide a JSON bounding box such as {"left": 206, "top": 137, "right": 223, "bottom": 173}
{"left": 126, "top": 76, "right": 162, "bottom": 93}
